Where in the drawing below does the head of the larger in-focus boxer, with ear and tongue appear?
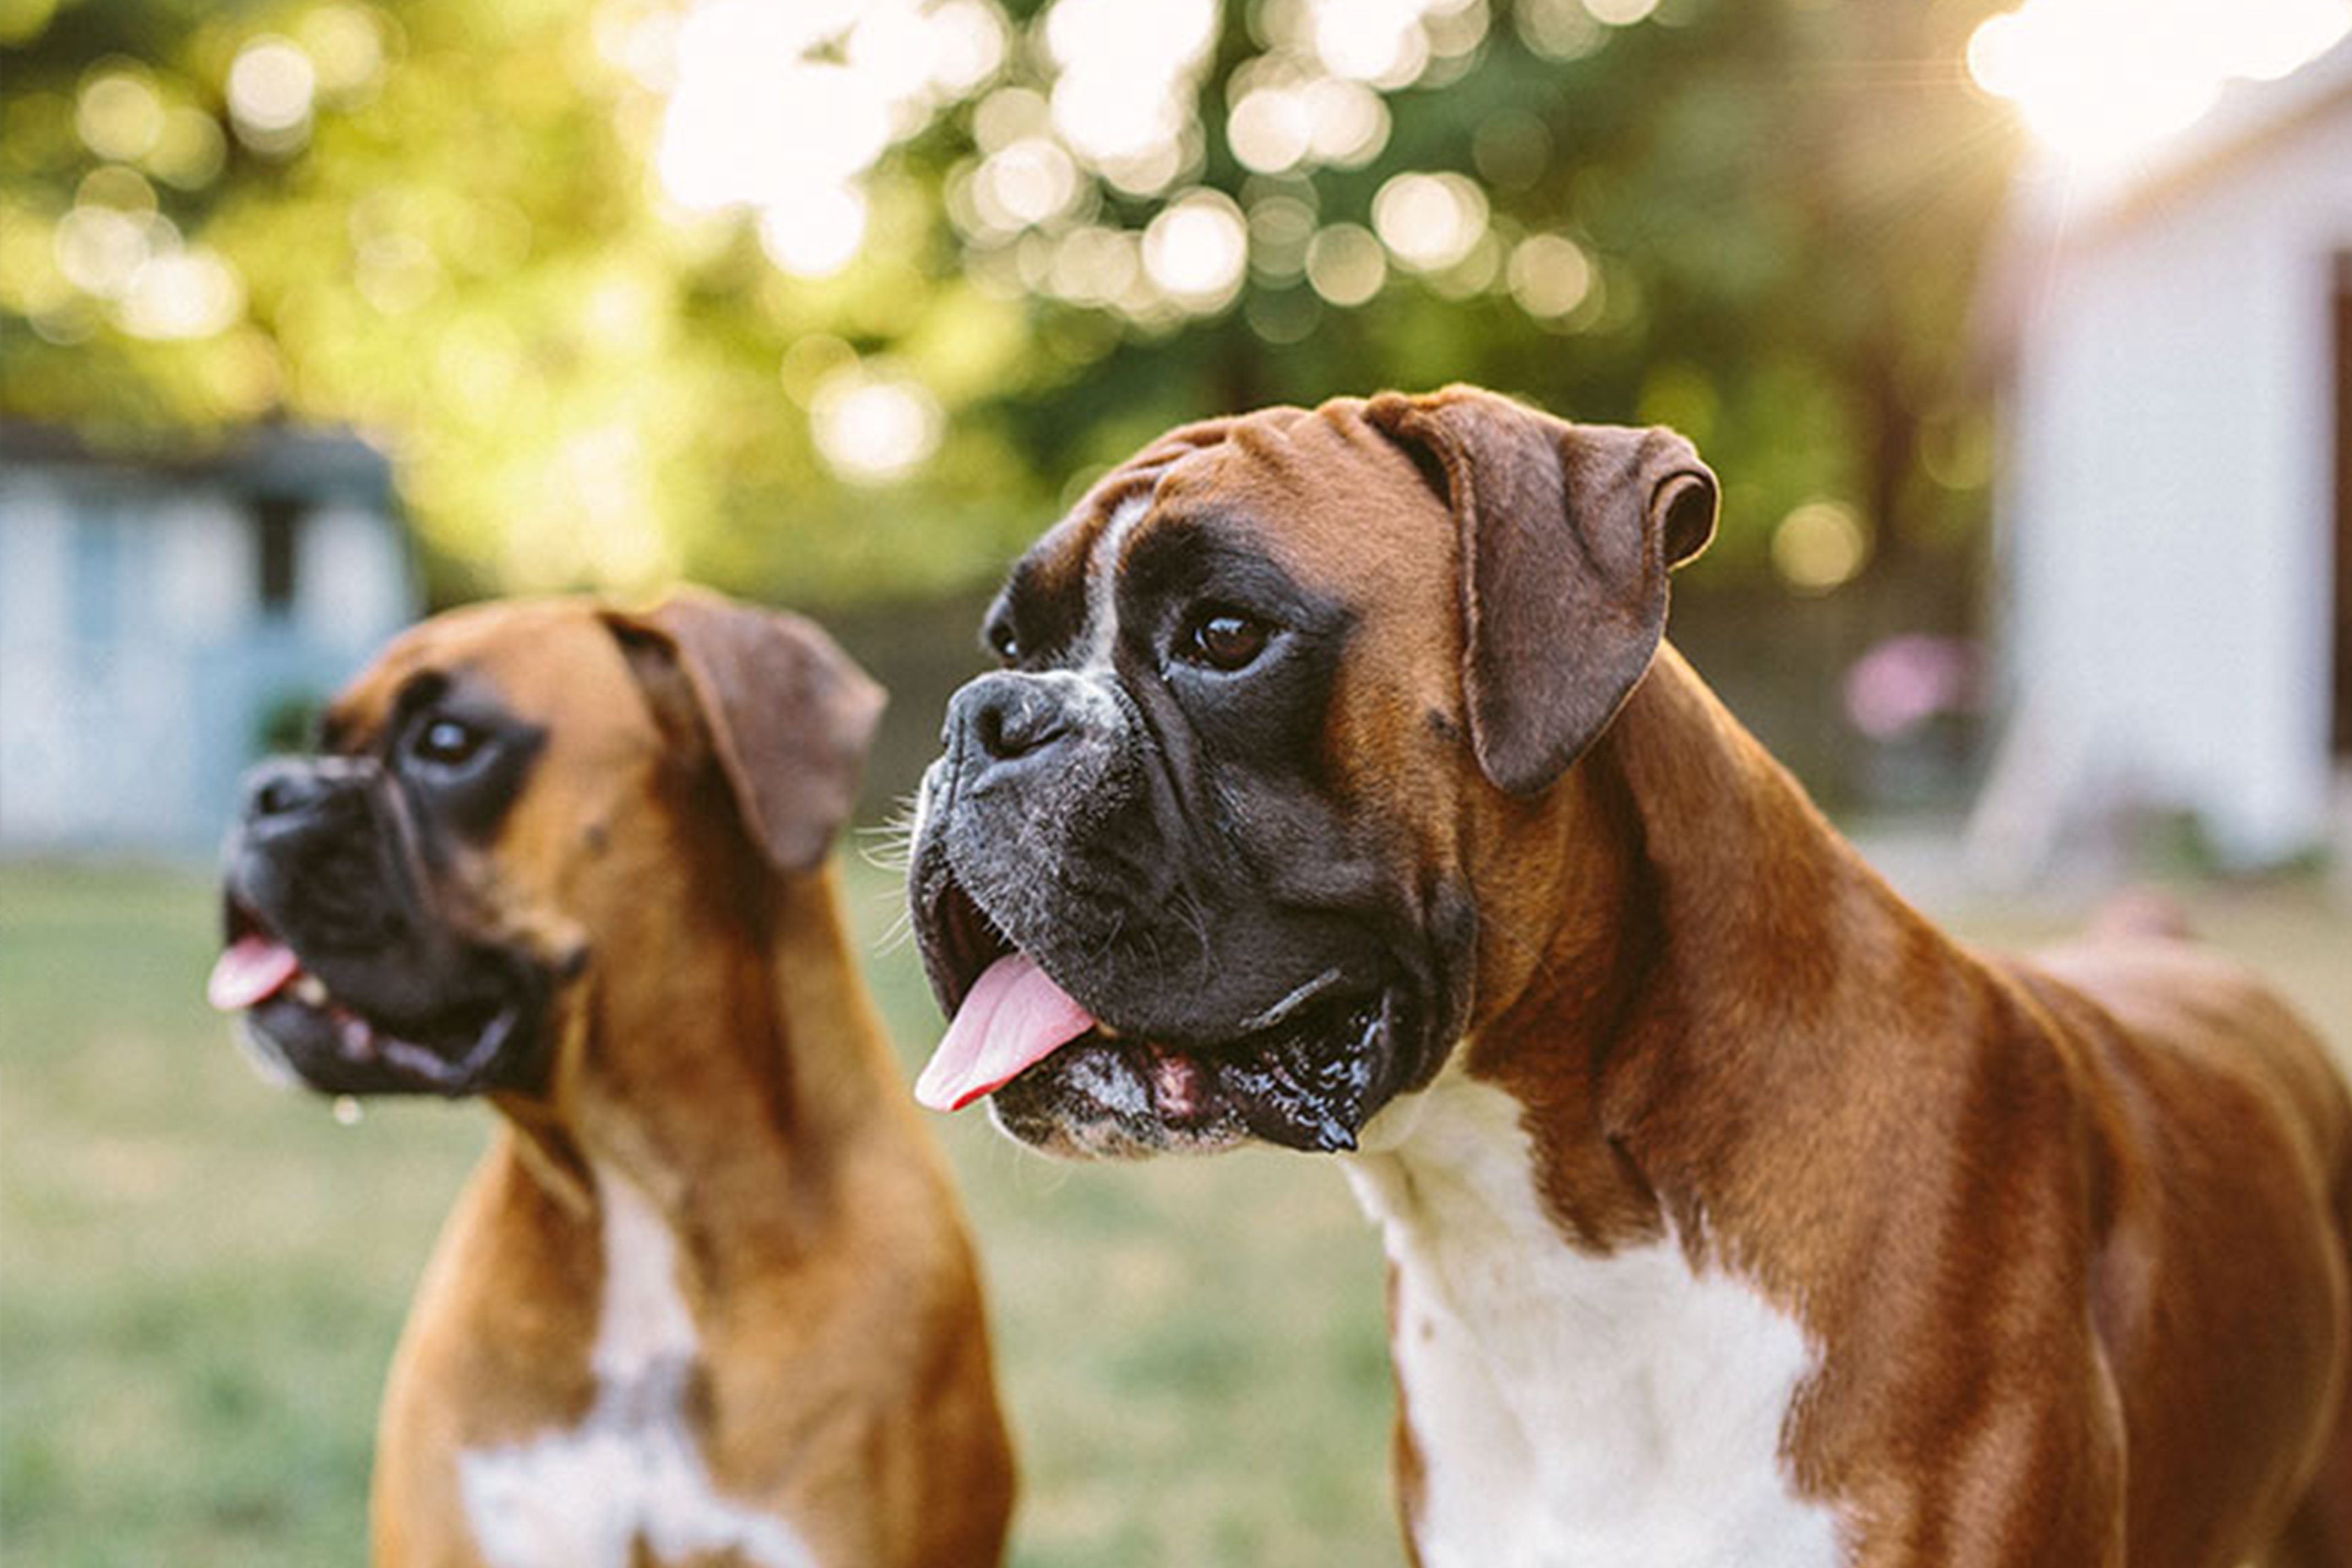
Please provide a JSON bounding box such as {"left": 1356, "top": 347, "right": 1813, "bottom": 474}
{"left": 910, "top": 388, "right": 1714, "bottom": 1155}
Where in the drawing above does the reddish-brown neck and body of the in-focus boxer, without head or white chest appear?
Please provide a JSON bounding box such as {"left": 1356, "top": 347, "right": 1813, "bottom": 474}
{"left": 1472, "top": 651, "right": 2352, "bottom": 1568}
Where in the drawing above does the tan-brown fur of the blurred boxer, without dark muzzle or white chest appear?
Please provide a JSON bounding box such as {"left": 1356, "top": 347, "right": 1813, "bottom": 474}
{"left": 331, "top": 602, "right": 1011, "bottom": 1568}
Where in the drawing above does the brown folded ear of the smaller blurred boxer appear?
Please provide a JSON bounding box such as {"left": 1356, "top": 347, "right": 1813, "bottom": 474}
{"left": 605, "top": 590, "right": 884, "bottom": 872}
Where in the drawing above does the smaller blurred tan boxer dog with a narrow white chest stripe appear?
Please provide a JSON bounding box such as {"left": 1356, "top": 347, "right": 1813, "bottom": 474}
{"left": 211, "top": 592, "right": 1011, "bottom": 1568}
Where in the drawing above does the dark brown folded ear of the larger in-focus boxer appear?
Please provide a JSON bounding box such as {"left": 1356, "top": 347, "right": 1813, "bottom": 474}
{"left": 1364, "top": 385, "right": 1714, "bottom": 794}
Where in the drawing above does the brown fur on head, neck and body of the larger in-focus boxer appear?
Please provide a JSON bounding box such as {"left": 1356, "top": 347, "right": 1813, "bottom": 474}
{"left": 1037, "top": 388, "right": 2352, "bottom": 1568}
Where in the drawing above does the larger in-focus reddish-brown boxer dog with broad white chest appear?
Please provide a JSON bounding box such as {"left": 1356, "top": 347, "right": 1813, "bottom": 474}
{"left": 910, "top": 388, "right": 2352, "bottom": 1568}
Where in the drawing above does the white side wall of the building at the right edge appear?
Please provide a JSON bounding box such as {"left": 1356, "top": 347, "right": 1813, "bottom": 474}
{"left": 2004, "top": 106, "right": 2352, "bottom": 861}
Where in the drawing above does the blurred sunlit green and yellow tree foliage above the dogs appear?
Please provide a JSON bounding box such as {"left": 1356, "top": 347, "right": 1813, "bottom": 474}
{"left": 0, "top": 0, "right": 2016, "bottom": 602}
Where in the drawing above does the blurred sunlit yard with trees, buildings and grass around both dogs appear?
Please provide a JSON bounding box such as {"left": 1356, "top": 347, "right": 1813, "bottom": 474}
{"left": 0, "top": 0, "right": 2352, "bottom": 1568}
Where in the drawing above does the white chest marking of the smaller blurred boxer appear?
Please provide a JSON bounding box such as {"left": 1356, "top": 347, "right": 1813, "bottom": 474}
{"left": 459, "top": 1168, "right": 814, "bottom": 1568}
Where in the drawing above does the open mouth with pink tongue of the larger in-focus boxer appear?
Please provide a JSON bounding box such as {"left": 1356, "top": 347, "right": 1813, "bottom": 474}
{"left": 915, "top": 879, "right": 1395, "bottom": 1152}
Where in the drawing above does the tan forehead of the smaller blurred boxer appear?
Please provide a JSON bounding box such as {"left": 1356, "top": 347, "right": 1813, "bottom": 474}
{"left": 322, "top": 600, "right": 635, "bottom": 750}
